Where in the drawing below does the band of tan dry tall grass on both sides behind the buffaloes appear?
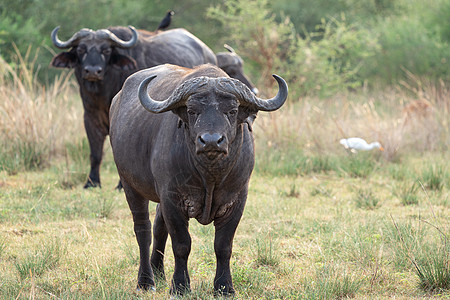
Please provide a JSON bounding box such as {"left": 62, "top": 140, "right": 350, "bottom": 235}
{"left": 0, "top": 46, "right": 450, "bottom": 172}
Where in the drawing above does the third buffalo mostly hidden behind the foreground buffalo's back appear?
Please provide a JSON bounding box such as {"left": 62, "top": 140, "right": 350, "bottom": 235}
{"left": 216, "top": 44, "right": 258, "bottom": 94}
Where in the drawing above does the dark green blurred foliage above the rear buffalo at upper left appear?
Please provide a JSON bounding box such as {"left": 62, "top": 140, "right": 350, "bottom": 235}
{"left": 0, "top": 0, "right": 223, "bottom": 80}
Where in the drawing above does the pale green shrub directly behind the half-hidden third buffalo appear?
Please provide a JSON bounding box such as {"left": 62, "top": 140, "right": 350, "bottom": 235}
{"left": 207, "top": 0, "right": 295, "bottom": 92}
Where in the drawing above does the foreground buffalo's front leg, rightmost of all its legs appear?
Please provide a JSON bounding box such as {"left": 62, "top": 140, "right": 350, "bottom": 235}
{"left": 214, "top": 199, "right": 245, "bottom": 295}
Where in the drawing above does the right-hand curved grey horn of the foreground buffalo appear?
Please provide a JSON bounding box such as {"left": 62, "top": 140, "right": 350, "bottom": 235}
{"left": 239, "top": 74, "right": 288, "bottom": 111}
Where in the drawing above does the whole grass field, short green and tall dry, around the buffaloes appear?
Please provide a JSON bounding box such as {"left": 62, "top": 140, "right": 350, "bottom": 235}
{"left": 0, "top": 56, "right": 450, "bottom": 299}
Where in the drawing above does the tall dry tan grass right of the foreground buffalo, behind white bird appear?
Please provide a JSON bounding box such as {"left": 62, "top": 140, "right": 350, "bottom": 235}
{"left": 255, "top": 74, "right": 450, "bottom": 161}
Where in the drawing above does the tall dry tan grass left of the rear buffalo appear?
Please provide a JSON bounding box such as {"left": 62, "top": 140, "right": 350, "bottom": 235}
{"left": 0, "top": 46, "right": 84, "bottom": 170}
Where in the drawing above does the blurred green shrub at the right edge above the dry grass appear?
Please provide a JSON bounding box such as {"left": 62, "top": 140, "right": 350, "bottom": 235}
{"left": 362, "top": 14, "right": 450, "bottom": 84}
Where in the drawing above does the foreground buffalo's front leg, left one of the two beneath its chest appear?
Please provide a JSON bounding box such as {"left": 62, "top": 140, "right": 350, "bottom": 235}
{"left": 161, "top": 199, "right": 191, "bottom": 295}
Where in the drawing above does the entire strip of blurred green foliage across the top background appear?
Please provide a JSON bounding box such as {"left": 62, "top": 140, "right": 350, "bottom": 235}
{"left": 0, "top": 0, "right": 450, "bottom": 96}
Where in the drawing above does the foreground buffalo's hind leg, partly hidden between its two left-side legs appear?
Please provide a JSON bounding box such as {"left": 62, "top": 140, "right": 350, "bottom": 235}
{"left": 150, "top": 204, "right": 168, "bottom": 280}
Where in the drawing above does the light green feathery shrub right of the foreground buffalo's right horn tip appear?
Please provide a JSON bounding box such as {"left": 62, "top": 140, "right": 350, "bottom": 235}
{"left": 286, "top": 17, "right": 379, "bottom": 97}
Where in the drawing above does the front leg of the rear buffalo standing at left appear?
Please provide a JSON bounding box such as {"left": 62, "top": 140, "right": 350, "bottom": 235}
{"left": 84, "top": 114, "right": 107, "bottom": 189}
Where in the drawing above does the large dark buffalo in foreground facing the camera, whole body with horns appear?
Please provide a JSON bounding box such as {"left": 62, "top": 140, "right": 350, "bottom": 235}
{"left": 110, "top": 65, "right": 288, "bottom": 294}
